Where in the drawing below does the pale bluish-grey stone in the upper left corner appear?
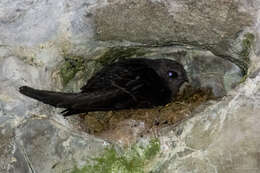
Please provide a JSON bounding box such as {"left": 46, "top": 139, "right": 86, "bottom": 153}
{"left": 0, "top": 0, "right": 95, "bottom": 46}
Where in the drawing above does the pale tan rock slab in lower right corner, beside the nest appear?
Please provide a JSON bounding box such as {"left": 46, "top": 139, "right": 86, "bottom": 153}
{"left": 150, "top": 57, "right": 260, "bottom": 173}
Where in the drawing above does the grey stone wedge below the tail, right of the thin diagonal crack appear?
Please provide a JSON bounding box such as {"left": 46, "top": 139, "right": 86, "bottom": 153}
{"left": 13, "top": 117, "right": 108, "bottom": 172}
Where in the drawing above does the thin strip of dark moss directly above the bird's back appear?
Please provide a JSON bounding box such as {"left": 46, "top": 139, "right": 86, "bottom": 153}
{"left": 98, "top": 47, "right": 145, "bottom": 65}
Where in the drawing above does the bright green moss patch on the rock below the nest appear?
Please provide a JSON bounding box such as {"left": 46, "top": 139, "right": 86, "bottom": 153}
{"left": 72, "top": 139, "right": 160, "bottom": 173}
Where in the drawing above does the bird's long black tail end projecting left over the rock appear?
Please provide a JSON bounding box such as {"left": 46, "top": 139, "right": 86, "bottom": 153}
{"left": 19, "top": 86, "right": 78, "bottom": 108}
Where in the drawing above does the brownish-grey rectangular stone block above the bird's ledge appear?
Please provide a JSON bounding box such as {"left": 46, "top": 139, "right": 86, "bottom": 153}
{"left": 95, "top": 0, "right": 253, "bottom": 45}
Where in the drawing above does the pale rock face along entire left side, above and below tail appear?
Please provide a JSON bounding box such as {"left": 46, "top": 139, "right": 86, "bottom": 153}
{"left": 0, "top": 0, "right": 108, "bottom": 173}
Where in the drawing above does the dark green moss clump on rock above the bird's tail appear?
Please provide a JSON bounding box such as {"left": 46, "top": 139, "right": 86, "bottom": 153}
{"left": 60, "top": 56, "right": 85, "bottom": 86}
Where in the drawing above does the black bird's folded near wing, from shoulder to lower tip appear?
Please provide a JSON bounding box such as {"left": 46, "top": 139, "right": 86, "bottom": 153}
{"left": 63, "top": 63, "right": 170, "bottom": 116}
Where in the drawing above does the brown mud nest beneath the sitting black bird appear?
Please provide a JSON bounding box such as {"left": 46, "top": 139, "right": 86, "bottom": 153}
{"left": 70, "top": 86, "right": 212, "bottom": 142}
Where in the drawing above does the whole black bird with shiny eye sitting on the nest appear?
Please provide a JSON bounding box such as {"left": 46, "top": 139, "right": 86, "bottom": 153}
{"left": 19, "top": 58, "right": 188, "bottom": 117}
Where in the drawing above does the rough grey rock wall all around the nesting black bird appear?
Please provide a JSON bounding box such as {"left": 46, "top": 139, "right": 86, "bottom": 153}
{"left": 0, "top": 0, "right": 260, "bottom": 173}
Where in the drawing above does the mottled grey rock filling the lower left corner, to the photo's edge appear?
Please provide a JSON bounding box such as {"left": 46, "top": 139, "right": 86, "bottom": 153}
{"left": 0, "top": 116, "right": 108, "bottom": 173}
